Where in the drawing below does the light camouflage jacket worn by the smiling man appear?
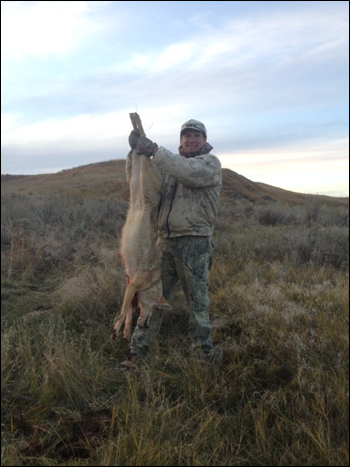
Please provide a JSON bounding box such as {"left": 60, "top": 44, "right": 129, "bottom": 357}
{"left": 126, "top": 146, "right": 222, "bottom": 238}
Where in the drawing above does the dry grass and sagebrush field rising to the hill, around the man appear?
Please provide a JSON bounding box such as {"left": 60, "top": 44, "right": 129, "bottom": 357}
{"left": 1, "top": 161, "right": 349, "bottom": 466}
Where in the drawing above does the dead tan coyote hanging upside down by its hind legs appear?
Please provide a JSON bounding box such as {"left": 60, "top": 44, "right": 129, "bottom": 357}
{"left": 112, "top": 113, "right": 170, "bottom": 340}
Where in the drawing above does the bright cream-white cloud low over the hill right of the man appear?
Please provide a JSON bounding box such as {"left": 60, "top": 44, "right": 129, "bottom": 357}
{"left": 219, "top": 138, "right": 349, "bottom": 196}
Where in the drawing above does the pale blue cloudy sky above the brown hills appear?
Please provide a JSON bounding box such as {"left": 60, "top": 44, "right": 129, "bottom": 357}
{"left": 1, "top": 0, "right": 349, "bottom": 196}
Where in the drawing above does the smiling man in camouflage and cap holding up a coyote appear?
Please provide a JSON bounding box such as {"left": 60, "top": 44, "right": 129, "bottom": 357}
{"left": 122, "top": 119, "right": 221, "bottom": 367}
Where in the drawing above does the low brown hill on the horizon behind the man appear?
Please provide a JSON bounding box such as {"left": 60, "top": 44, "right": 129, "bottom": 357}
{"left": 1, "top": 159, "right": 349, "bottom": 206}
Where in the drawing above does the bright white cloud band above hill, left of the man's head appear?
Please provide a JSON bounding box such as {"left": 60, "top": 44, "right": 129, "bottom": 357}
{"left": 1, "top": 104, "right": 187, "bottom": 174}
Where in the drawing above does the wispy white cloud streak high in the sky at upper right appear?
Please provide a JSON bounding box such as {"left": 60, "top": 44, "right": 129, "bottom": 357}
{"left": 119, "top": 4, "right": 348, "bottom": 72}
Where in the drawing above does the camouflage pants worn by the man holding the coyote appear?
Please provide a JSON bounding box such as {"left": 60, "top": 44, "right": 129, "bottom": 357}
{"left": 130, "top": 236, "right": 213, "bottom": 361}
